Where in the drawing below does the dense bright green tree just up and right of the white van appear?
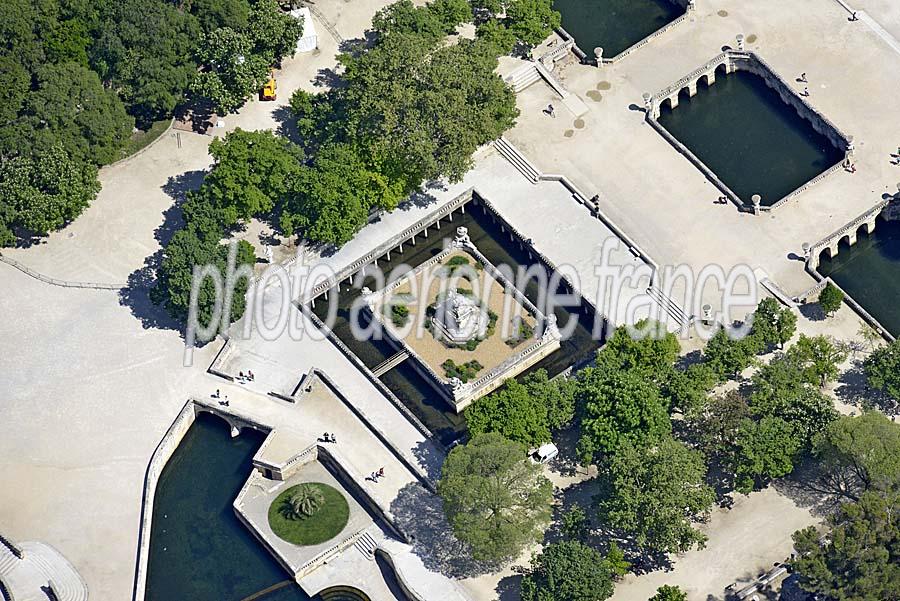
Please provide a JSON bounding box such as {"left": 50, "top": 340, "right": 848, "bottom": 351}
{"left": 576, "top": 368, "right": 672, "bottom": 463}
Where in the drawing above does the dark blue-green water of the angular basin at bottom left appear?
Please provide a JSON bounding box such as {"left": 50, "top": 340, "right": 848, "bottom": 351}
{"left": 145, "top": 413, "right": 310, "bottom": 601}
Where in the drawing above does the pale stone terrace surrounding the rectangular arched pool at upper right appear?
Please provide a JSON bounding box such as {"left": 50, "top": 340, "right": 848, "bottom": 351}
{"left": 507, "top": 0, "right": 900, "bottom": 302}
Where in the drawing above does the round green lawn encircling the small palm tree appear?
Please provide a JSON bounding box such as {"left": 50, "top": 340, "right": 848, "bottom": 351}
{"left": 269, "top": 482, "right": 350, "bottom": 545}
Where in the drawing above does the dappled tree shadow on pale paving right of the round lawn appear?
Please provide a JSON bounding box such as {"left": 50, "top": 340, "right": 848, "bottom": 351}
{"left": 390, "top": 483, "right": 502, "bottom": 578}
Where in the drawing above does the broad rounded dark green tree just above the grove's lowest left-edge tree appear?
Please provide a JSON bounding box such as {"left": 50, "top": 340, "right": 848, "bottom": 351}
{"left": 23, "top": 62, "right": 134, "bottom": 165}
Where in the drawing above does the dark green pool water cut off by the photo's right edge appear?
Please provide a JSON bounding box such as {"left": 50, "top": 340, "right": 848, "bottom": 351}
{"left": 818, "top": 221, "right": 900, "bottom": 337}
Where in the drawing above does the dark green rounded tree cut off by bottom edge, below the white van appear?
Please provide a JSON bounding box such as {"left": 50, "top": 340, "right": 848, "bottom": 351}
{"left": 522, "top": 541, "right": 613, "bottom": 601}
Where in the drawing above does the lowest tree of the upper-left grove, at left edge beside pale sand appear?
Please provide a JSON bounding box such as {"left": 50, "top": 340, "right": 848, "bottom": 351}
{"left": 0, "top": 145, "right": 100, "bottom": 246}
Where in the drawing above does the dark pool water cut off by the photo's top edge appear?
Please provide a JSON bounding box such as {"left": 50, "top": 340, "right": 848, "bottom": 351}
{"left": 553, "top": 0, "right": 684, "bottom": 59}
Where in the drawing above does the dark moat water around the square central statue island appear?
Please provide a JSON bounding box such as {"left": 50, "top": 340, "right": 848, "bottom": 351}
{"left": 314, "top": 198, "right": 600, "bottom": 444}
